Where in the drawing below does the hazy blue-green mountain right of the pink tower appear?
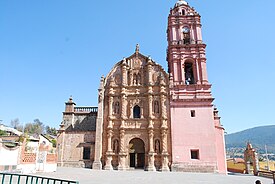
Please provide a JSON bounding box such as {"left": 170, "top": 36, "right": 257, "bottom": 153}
{"left": 225, "top": 125, "right": 275, "bottom": 154}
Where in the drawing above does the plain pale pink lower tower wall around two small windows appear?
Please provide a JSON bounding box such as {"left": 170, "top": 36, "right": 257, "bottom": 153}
{"left": 171, "top": 107, "right": 217, "bottom": 165}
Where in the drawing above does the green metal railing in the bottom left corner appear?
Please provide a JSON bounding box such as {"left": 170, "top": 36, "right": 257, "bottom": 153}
{"left": 0, "top": 173, "right": 79, "bottom": 184}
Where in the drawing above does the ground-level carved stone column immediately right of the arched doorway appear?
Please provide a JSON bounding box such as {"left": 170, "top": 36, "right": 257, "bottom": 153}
{"left": 147, "top": 129, "right": 156, "bottom": 171}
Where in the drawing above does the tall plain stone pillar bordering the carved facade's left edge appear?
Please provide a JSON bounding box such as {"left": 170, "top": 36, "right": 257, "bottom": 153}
{"left": 93, "top": 76, "right": 105, "bottom": 170}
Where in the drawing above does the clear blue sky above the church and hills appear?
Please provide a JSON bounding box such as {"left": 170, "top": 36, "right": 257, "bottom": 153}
{"left": 0, "top": 0, "right": 275, "bottom": 133}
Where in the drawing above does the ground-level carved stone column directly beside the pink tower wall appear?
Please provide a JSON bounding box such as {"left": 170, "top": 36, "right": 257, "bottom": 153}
{"left": 161, "top": 129, "right": 170, "bottom": 172}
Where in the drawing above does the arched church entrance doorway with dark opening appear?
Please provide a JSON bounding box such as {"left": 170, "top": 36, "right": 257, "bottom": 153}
{"left": 129, "top": 138, "right": 145, "bottom": 169}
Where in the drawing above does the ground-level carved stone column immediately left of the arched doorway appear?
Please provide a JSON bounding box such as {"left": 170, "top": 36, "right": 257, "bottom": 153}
{"left": 118, "top": 128, "right": 127, "bottom": 171}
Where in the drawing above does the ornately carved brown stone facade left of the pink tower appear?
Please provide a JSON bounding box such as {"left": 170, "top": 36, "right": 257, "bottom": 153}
{"left": 102, "top": 49, "right": 171, "bottom": 171}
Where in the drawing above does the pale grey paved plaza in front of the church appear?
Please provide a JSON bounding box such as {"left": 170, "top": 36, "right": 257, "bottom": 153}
{"left": 34, "top": 168, "right": 273, "bottom": 184}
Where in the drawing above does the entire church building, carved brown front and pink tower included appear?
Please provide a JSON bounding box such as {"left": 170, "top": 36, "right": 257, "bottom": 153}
{"left": 57, "top": 0, "right": 226, "bottom": 173}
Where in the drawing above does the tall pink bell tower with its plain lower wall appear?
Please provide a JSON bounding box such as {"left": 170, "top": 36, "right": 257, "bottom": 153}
{"left": 167, "top": 0, "right": 226, "bottom": 173}
